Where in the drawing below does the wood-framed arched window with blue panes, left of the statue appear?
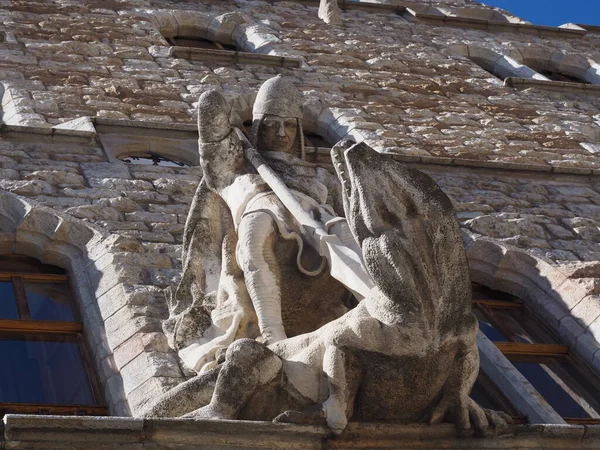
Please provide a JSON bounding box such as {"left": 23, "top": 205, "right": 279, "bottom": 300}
{"left": 0, "top": 255, "right": 107, "bottom": 415}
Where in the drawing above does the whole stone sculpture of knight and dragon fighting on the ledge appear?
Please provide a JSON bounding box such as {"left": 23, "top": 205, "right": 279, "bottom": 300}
{"left": 146, "top": 77, "right": 510, "bottom": 435}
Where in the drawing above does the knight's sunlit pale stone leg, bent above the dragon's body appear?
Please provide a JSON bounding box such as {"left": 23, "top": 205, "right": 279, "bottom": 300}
{"left": 237, "top": 212, "right": 287, "bottom": 344}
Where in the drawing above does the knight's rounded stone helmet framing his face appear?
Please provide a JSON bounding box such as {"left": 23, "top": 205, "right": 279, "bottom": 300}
{"left": 252, "top": 75, "right": 305, "bottom": 159}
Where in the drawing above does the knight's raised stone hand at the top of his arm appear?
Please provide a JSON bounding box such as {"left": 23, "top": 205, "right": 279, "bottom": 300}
{"left": 198, "top": 90, "right": 231, "bottom": 144}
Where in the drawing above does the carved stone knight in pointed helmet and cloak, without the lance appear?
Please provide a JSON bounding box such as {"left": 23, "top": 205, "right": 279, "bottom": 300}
{"left": 165, "top": 76, "right": 356, "bottom": 372}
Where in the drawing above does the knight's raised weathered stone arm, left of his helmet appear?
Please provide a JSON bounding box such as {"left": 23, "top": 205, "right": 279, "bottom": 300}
{"left": 198, "top": 90, "right": 245, "bottom": 193}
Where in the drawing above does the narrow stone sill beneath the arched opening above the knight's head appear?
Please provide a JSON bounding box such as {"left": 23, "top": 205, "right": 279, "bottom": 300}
{"left": 169, "top": 46, "right": 302, "bottom": 69}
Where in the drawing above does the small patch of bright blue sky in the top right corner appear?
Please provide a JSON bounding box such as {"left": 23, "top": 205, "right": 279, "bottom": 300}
{"left": 478, "top": 0, "right": 600, "bottom": 26}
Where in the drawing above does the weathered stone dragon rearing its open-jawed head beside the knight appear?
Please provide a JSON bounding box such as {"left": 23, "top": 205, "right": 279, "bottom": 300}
{"left": 147, "top": 76, "right": 510, "bottom": 434}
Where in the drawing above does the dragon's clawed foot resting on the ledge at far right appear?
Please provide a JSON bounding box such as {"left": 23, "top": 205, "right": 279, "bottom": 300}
{"left": 429, "top": 396, "right": 512, "bottom": 437}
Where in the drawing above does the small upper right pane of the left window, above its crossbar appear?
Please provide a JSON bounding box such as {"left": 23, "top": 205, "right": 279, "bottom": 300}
{"left": 25, "top": 283, "right": 75, "bottom": 322}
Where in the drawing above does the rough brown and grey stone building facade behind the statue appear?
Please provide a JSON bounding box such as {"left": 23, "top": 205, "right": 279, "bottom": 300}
{"left": 0, "top": 0, "right": 600, "bottom": 448}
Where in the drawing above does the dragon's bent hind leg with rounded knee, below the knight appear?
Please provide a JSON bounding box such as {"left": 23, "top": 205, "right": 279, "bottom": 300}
{"left": 187, "top": 339, "right": 283, "bottom": 419}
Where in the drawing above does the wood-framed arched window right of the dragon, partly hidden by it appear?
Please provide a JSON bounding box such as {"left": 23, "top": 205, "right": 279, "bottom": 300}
{"left": 473, "top": 285, "right": 600, "bottom": 424}
